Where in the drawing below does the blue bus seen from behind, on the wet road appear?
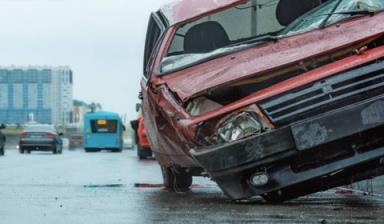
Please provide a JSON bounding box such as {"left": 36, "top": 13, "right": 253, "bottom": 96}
{"left": 83, "top": 112, "right": 125, "bottom": 152}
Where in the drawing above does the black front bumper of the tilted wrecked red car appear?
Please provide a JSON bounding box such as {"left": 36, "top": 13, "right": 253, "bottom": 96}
{"left": 190, "top": 96, "right": 384, "bottom": 199}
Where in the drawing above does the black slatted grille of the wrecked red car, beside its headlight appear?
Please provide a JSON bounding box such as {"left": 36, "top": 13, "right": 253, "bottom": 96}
{"left": 260, "top": 61, "right": 384, "bottom": 126}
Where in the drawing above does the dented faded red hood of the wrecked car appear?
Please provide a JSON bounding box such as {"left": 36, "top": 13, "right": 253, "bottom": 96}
{"left": 161, "top": 13, "right": 384, "bottom": 102}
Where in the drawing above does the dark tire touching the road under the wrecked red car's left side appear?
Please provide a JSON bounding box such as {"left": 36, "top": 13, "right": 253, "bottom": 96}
{"left": 161, "top": 166, "right": 193, "bottom": 192}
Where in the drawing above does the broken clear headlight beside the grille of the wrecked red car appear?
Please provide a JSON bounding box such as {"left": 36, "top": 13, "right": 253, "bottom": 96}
{"left": 217, "top": 112, "right": 263, "bottom": 142}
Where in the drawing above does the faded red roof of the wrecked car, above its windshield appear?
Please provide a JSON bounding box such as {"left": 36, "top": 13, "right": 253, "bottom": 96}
{"left": 160, "top": 0, "right": 247, "bottom": 26}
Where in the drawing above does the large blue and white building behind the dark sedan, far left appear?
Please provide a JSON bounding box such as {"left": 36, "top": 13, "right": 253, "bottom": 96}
{"left": 0, "top": 66, "right": 73, "bottom": 125}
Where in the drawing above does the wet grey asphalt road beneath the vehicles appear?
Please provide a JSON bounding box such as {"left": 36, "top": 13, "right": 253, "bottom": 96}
{"left": 0, "top": 150, "right": 384, "bottom": 224}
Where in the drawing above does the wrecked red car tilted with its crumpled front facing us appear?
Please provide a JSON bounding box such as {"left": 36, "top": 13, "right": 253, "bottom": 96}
{"left": 141, "top": 0, "right": 384, "bottom": 201}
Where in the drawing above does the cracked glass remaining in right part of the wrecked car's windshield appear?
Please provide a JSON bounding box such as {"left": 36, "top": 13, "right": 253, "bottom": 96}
{"left": 280, "top": 0, "right": 384, "bottom": 36}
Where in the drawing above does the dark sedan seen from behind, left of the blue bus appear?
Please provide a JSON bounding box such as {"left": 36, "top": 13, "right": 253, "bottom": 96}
{"left": 19, "top": 125, "right": 63, "bottom": 154}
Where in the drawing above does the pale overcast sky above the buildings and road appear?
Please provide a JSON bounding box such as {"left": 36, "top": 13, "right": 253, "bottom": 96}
{"left": 0, "top": 0, "right": 170, "bottom": 117}
